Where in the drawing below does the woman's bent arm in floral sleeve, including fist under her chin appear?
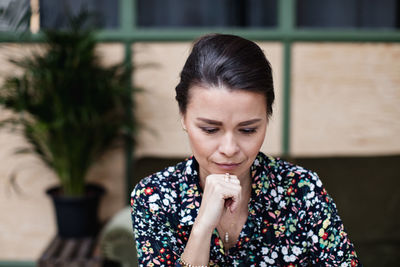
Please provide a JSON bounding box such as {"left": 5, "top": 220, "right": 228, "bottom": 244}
{"left": 131, "top": 175, "right": 241, "bottom": 266}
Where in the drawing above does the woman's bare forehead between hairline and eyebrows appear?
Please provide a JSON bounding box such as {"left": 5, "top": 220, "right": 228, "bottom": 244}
{"left": 186, "top": 86, "right": 267, "bottom": 121}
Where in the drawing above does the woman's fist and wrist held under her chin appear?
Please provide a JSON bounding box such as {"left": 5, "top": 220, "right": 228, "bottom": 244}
{"left": 195, "top": 174, "right": 241, "bottom": 232}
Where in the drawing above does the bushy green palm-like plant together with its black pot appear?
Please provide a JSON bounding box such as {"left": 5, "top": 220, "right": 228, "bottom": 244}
{"left": 0, "top": 14, "right": 133, "bottom": 237}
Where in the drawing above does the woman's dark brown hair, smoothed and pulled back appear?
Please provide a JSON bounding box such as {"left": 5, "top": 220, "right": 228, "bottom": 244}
{"left": 175, "top": 34, "right": 275, "bottom": 116}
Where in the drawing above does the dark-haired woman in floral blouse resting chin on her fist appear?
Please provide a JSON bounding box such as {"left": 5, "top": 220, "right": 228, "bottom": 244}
{"left": 131, "top": 34, "right": 361, "bottom": 266}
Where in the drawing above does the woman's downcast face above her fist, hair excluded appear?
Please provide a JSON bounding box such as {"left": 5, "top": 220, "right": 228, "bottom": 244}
{"left": 182, "top": 86, "right": 268, "bottom": 182}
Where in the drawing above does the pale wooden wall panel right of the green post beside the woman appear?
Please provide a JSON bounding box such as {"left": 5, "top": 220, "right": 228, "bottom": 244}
{"left": 291, "top": 43, "right": 400, "bottom": 156}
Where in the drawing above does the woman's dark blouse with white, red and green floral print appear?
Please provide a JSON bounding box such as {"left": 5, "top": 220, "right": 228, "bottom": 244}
{"left": 131, "top": 153, "right": 362, "bottom": 267}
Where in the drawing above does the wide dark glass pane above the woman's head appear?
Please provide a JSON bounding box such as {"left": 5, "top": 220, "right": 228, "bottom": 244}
{"left": 136, "top": 0, "right": 277, "bottom": 28}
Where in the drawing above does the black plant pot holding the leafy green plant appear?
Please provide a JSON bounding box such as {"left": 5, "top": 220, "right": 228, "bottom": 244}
{"left": 46, "top": 184, "right": 105, "bottom": 238}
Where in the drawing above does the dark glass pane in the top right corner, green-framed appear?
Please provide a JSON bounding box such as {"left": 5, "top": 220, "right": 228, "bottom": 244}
{"left": 297, "top": 0, "right": 400, "bottom": 29}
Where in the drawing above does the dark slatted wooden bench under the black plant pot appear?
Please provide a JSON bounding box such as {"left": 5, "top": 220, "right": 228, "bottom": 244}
{"left": 38, "top": 236, "right": 103, "bottom": 267}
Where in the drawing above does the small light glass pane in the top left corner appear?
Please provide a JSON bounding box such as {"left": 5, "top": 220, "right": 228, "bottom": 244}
{"left": 0, "top": 0, "right": 30, "bottom": 32}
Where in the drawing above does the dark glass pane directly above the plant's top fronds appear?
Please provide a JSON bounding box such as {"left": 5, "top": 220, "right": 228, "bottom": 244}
{"left": 40, "top": 0, "right": 119, "bottom": 29}
